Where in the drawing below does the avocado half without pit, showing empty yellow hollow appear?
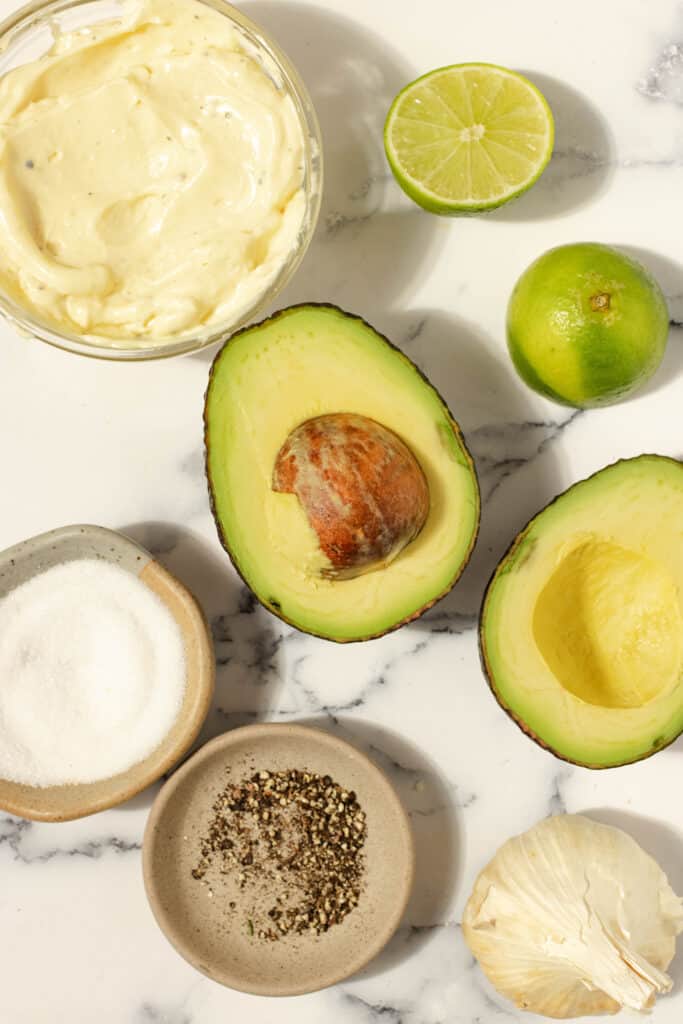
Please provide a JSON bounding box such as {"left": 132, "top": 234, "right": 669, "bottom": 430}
{"left": 479, "top": 455, "right": 683, "bottom": 768}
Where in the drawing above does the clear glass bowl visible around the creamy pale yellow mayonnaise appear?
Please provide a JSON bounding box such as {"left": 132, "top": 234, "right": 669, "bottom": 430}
{"left": 0, "top": 0, "right": 323, "bottom": 360}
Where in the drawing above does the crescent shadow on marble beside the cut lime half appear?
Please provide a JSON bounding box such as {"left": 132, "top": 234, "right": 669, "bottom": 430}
{"left": 489, "top": 70, "right": 614, "bottom": 224}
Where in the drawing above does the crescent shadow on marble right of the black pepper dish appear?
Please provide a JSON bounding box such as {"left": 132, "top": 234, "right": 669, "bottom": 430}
{"left": 303, "top": 716, "right": 463, "bottom": 978}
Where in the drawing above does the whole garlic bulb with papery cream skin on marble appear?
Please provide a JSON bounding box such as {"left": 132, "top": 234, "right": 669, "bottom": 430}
{"left": 463, "top": 814, "right": 683, "bottom": 1018}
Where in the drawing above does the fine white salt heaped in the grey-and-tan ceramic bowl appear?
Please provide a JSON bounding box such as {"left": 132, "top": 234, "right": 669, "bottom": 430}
{"left": 0, "top": 559, "right": 185, "bottom": 786}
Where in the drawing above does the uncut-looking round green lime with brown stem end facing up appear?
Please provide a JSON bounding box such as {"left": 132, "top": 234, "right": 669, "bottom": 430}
{"left": 507, "top": 242, "right": 669, "bottom": 409}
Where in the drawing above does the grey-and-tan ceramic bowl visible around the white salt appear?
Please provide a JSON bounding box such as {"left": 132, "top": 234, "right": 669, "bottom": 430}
{"left": 0, "top": 525, "right": 215, "bottom": 821}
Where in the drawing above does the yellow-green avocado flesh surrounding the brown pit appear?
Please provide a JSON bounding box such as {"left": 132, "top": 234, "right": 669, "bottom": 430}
{"left": 205, "top": 305, "right": 479, "bottom": 640}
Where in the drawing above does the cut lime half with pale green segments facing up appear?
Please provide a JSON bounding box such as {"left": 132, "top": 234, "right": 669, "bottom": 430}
{"left": 384, "top": 63, "right": 555, "bottom": 214}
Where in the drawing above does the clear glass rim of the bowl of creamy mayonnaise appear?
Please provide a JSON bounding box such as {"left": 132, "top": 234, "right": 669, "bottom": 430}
{"left": 0, "top": 0, "right": 324, "bottom": 362}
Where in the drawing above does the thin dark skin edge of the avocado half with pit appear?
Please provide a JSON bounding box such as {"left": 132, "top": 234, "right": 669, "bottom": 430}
{"left": 203, "top": 302, "right": 481, "bottom": 644}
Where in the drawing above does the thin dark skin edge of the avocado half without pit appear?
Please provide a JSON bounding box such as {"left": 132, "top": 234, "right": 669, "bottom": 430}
{"left": 477, "top": 452, "right": 683, "bottom": 771}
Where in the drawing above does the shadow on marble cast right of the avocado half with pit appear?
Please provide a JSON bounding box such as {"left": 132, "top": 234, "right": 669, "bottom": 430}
{"left": 379, "top": 309, "right": 565, "bottom": 632}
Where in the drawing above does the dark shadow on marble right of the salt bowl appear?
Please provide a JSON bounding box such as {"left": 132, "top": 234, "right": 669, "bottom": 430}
{"left": 121, "top": 522, "right": 284, "bottom": 810}
